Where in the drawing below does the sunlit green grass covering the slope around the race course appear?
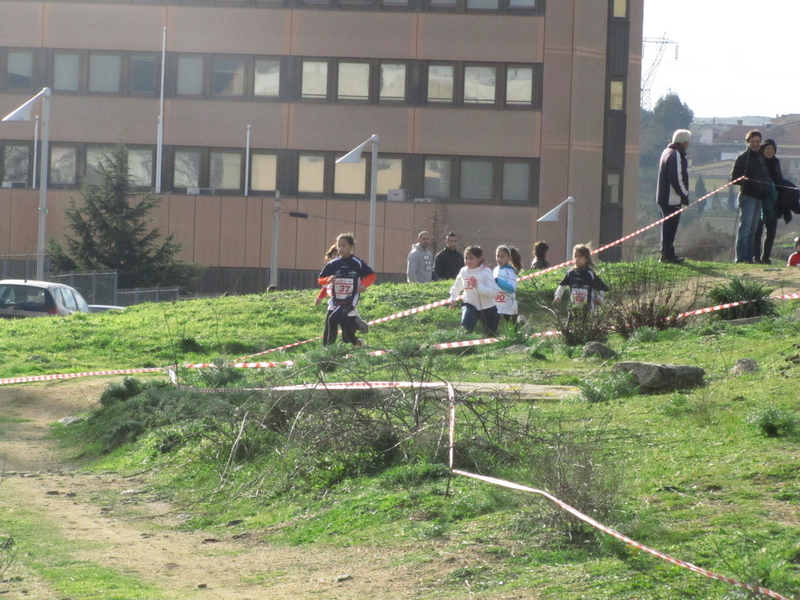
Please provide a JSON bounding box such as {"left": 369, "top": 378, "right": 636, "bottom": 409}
{"left": 0, "top": 263, "right": 800, "bottom": 600}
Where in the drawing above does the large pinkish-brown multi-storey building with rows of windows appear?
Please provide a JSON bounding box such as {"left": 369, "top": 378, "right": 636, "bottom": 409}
{"left": 0, "top": 0, "right": 643, "bottom": 292}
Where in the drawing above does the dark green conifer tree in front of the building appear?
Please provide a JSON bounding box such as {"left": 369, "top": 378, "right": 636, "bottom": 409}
{"left": 48, "top": 143, "right": 201, "bottom": 288}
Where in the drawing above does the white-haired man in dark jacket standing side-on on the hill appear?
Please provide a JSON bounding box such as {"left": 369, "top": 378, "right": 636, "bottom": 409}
{"left": 656, "top": 129, "right": 692, "bottom": 265}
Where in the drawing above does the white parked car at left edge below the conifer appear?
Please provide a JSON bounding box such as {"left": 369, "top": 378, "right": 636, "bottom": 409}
{"left": 0, "top": 279, "right": 89, "bottom": 319}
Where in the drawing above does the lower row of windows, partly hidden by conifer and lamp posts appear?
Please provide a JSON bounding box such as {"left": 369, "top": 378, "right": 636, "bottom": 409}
{"left": 0, "top": 142, "right": 539, "bottom": 204}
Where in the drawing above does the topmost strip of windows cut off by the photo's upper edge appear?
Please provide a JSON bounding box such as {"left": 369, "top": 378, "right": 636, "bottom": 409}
{"left": 40, "top": 0, "right": 548, "bottom": 15}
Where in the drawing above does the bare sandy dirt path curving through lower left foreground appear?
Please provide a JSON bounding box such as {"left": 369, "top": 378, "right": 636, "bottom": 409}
{"left": 0, "top": 378, "right": 535, "bottom": 600}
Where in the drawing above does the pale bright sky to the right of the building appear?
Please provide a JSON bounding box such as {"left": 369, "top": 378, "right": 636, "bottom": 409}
{"left": 642, "top": 0, "right": 800, "bottom": 117}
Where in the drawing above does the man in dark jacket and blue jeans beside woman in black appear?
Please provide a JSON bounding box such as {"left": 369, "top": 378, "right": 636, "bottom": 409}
{"left": 731, "top": 129, "right": 774, "bottom": 263}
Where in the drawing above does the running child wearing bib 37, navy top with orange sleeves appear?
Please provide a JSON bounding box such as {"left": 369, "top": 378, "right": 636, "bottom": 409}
{"left": 318, "top": 233, "right": 375, "bottom": 346}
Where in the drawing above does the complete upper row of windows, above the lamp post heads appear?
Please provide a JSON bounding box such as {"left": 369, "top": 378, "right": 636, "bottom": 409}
{"left": 0, "top": 49, "right": 543, "bottom": 109}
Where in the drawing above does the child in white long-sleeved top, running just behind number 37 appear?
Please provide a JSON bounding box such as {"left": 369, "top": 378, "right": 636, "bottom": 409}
{"left": 450, "top": 246, "right": 500, "bottom": 337}
